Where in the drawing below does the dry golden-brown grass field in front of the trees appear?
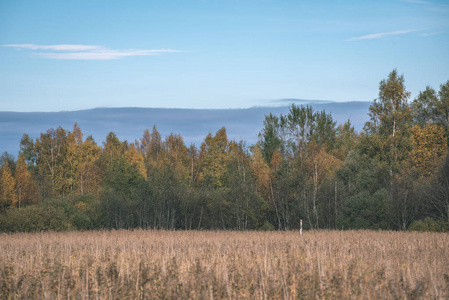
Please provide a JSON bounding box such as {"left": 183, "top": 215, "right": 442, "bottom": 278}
{"left": 0, "top": 230, "right": 449, "bottom": 299}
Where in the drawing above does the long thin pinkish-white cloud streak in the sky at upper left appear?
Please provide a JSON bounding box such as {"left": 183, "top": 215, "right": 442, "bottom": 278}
{"left": 3, "top": 44, "right": 181, "bottom": 60}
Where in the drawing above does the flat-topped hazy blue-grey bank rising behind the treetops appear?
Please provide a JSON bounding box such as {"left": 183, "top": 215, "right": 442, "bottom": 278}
{"left": 0, "top": 99, "right": 371, "bottom": 156}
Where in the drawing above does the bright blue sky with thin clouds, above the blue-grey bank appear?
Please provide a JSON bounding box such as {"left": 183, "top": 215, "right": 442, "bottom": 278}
{"left": 0, "top": 0, "right": 449, "bottom": 111}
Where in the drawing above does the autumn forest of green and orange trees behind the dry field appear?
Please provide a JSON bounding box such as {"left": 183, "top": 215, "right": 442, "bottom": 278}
{"left": 0, "top": 70, "right": 449, "bottom": 232}
